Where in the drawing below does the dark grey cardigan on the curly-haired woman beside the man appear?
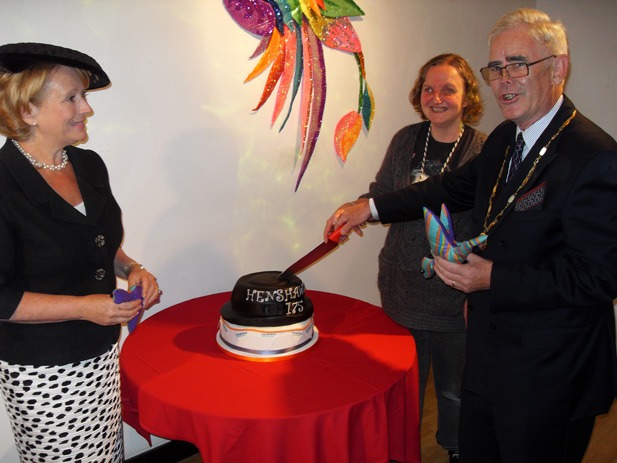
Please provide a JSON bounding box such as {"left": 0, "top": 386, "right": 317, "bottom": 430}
{"left": 363, "top": 122, "right": 486, "bottom": 332}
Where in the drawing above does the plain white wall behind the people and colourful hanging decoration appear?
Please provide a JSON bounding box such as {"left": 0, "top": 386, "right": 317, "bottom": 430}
{"left": 0, "top": 0, "right": 617, "bottom": 462}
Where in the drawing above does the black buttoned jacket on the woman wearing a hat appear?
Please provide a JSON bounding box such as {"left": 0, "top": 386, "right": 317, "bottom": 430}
{"left": 0, "top": 140, "right": 122, "bottom": 365}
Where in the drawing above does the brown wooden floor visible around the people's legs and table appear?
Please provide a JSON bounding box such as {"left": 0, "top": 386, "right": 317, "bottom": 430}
{"left": 179, "top": 379, "right": 617, "bottom": 463}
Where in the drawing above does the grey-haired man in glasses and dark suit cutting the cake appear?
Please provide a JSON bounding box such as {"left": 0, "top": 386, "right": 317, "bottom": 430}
{"left": 325, "top": 9, "right": 617, "bottom": 463}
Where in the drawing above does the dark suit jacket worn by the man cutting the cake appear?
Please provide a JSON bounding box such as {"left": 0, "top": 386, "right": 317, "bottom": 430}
{"left": 375, "top": 98, "right": 617, "bottom": 424}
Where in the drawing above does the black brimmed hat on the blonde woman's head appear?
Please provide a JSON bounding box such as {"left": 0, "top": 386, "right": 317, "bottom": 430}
{"left": 0, "top": 42, "right": 110, "bottom": 90}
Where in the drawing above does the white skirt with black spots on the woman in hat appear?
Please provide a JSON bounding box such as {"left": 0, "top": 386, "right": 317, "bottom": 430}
{"left": 0, "top": 344, "right": 124, "bottom": 463}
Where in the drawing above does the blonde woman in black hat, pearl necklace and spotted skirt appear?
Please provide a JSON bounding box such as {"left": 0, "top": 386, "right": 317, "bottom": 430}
{"left": 0, "top": 43, "right": 160, "bottom": 462}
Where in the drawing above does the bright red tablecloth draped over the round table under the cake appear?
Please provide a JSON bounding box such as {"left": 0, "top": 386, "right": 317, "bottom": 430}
{"left": 120, "top": 291, "right": 420, "bottom": 463}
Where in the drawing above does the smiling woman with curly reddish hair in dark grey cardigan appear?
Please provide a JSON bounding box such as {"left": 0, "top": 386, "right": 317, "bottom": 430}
{"left": 364, "top": 54, "right": 486, "bottom": 462}
